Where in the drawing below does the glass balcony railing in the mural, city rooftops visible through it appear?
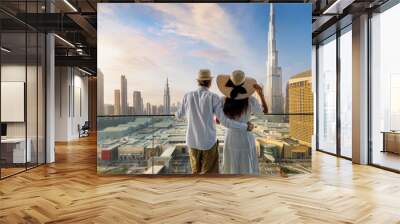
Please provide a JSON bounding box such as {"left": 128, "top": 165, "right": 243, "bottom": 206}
{"left": 97, "top": 114, "right": 313, "bottom": 175}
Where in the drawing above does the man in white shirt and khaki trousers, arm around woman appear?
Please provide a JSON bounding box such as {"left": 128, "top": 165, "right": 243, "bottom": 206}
{"left": 175, "top": 69, "right": 254, "bottom": 174}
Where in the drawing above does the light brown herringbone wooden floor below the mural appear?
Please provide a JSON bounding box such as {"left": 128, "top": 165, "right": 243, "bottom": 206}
{"left": 0, "top": 138, "right": 400, "bottom": 224}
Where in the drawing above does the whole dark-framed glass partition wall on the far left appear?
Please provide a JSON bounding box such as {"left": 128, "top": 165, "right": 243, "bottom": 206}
{"left": 0, "top": 0, "right": 45, "bottom": 178}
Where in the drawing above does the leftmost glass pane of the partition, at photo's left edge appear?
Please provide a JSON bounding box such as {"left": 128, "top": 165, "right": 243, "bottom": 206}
{"left": 0, "top": 32, "right": 27, "bottom": 177}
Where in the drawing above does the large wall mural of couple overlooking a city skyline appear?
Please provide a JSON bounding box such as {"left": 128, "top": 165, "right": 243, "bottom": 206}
{"left": 97, "top": 3, "right": 314, "bottom": 176}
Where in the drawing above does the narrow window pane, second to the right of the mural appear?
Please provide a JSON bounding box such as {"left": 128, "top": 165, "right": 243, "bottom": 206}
{"left": 339, "top": 26, "right": 353, "bottom": 158}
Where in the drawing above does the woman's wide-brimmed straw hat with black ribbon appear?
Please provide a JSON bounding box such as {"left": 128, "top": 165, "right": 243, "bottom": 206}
{"left": 217, "top": 70, "right": 257, "bottom": 100}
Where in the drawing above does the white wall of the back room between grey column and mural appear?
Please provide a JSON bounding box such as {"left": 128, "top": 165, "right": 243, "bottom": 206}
{"left": 55, "top": 67, "right": 88, "bottom": 141}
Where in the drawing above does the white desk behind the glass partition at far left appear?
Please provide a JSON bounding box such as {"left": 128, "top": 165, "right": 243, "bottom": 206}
{"left": 1, "top": 138, "right": 32, "bottom": 163}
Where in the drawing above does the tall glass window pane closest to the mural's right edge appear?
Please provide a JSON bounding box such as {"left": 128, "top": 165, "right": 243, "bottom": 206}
{"left": 318, "top": 36, "right": 337, "bottom": 153}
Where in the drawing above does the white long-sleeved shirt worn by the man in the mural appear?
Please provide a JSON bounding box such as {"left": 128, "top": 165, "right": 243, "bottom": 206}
{"left": 175, "top": 87, "right": 247, "bottom": 150}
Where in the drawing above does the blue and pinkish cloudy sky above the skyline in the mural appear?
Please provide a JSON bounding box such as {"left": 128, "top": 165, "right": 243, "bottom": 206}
{"left": 97, "top": 3, "right": 311, "bottom": 105}
